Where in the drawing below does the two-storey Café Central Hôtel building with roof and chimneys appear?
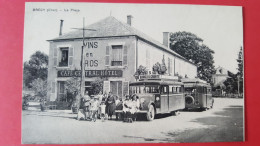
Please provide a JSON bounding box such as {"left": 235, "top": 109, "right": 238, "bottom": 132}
{"left": 48, "top": 16, "right": 197, "bottom": 101}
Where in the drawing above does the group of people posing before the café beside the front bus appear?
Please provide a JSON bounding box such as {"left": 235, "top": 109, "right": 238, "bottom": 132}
{"left": 78, "top": 92, "right": 140, "bottom": 122}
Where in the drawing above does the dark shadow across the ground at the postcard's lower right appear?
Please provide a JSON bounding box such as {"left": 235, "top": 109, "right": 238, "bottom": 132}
{"left": 124, "top": 106, "right": 243, "bottom": 143}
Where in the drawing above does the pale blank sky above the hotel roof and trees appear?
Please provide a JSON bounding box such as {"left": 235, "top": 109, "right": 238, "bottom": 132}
{"left": 23, "top": 2, "right": 243, "bottom": 73}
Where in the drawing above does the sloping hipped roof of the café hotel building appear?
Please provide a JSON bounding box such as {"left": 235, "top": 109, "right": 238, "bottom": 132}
{"left": 48, "top": 16, "right": 194, "bottom": 64}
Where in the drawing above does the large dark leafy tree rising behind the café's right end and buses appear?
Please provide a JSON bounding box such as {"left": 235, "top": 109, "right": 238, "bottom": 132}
{"left": 170, "top": 31, "right": 215, "bottom": 83}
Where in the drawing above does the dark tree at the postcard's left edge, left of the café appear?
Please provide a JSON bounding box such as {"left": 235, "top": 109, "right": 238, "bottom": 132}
{"left": 23, "top": 51, "right": 48, "bottom": 88}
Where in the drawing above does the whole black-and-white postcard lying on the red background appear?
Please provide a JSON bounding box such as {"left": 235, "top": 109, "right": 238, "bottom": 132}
{"left": 21, "top": 2, "right": 246, "bottom": 144}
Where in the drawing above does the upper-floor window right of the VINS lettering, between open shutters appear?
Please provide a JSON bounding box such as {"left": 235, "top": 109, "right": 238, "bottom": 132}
{"left": 111, "top": 45, "right": 123, "bottom": 66}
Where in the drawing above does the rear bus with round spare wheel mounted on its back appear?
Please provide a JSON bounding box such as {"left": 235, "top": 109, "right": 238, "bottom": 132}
{"left": 182, "top": 78, "right": 214, "bottom": 110}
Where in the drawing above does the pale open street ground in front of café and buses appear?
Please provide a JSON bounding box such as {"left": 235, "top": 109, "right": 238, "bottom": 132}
{"left": 22, "top": 98, "right": 244, "bottom": 144}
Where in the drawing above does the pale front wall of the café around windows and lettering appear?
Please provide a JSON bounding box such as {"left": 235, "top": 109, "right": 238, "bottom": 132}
{"left": 48, "top": 36, "right": 136, "bottom": 100}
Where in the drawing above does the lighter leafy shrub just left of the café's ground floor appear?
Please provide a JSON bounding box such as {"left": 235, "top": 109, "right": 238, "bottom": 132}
{"left": 30, "top": 78, "right": 49, "bottom": 99}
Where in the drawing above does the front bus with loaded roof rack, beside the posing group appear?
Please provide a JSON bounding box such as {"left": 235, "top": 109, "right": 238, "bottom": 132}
{"left": 116, "top": 75, "right": 185, "bottom": 121}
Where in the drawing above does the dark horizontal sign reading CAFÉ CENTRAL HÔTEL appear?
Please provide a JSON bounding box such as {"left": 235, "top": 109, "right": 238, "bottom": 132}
{"left": 57, "top": 70, "right": 123, "bottom": 77}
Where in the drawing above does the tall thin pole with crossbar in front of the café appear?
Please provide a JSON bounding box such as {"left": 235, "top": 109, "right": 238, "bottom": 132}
{"left": 72, "top": 17, "right": 96, "bottom": 97}
